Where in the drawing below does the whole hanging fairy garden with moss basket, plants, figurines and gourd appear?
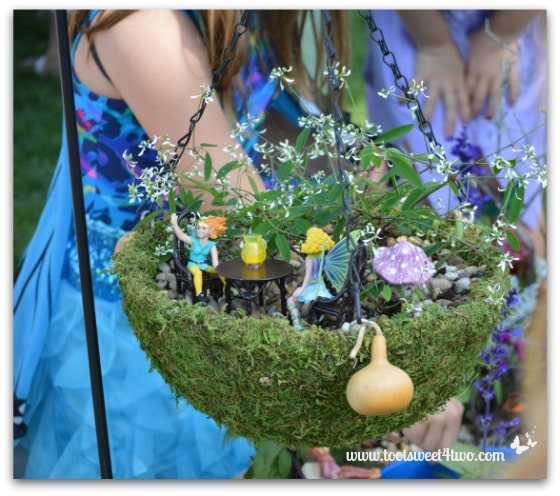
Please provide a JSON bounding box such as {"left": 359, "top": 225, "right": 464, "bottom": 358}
{"left": 114, "top": 13, "right": 542, "bottom": 478}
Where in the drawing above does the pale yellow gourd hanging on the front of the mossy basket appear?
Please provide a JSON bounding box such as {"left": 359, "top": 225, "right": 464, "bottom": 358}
{"left": 346, "top": 322, "right": 414, "bottom": 416}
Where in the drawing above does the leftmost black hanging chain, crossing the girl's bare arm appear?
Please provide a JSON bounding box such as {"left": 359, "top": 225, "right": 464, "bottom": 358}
{"left": 170, "top": 10, "right": 249, "bottom": 168}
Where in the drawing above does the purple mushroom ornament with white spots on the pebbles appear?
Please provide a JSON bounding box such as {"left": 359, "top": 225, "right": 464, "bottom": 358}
{"left": 373, "top": 239, "right": 436, "bottom": 285}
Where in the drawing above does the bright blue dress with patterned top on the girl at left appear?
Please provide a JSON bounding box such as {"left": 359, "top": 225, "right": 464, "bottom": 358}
{"left": 13, "top": 9, "right": 302, "bottom": 479}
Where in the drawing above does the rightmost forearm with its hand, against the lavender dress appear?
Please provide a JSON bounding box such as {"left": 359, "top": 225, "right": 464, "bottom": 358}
{"left": 467, "top": 10, "right": 538, "bottom": 118}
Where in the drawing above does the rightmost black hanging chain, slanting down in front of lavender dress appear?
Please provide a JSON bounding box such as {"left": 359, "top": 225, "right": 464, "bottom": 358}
{"left": 358, "top": 12, "right": 441, "bottom": 152}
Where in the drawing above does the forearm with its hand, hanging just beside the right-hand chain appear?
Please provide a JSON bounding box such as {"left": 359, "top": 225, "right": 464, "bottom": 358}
{"left": 399, "top": 10, "right": 470, "bottom": 136}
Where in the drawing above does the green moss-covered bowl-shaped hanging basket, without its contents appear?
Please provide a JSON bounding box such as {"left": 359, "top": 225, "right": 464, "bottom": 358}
{"left": 114, "top": 219, "right": 509, "bottom": 448}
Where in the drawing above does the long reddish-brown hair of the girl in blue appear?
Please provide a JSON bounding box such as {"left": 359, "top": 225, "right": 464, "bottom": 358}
{"left": 69, "top": 10, "right": 350, "bottom": 110}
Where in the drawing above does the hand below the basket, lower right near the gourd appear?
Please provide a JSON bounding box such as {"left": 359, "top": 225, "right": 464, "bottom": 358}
{"left": 403, "top": 398, "right": 464, "bottom": 451}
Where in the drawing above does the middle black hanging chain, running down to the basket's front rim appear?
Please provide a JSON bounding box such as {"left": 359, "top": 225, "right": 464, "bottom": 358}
{"left": 321, "top": 10, "right": 362, "bottom": 324}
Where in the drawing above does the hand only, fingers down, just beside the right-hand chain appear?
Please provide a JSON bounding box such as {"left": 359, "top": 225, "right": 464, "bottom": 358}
{"left": 415, "top": 41, "right": 471, "bottom": 136}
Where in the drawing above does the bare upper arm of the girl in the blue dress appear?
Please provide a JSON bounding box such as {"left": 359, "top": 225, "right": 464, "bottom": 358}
{"left": 79, "top": 9, "right": 264, "bottom": 205}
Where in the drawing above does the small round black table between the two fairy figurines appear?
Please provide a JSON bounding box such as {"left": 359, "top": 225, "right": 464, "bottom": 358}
{"left": 216, "top": 258, "right": 294, "bottom": 315}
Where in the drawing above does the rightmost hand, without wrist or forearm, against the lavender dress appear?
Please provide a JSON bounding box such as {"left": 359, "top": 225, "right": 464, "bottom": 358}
{"left": 467, "top": 28, "right": 519, "bottom": 119}
